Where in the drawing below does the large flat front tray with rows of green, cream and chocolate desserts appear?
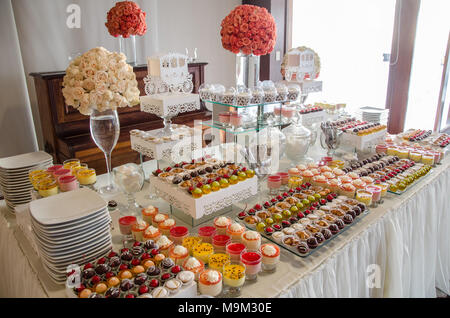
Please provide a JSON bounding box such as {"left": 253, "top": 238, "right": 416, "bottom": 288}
{"left": 237, "top": 182, "right": 369, "bottom": 257}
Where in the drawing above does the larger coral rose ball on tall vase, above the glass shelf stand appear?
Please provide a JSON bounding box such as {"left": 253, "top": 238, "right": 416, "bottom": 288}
{"left": 220, "top": 5, "right": 277, "bottom": 55}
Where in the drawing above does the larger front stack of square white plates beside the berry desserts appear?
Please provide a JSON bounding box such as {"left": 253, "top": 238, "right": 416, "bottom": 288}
{"left": 30, "top": 188, "right": 112, "bottom": 284}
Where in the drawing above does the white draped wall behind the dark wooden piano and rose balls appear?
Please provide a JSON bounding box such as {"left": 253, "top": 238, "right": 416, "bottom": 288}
{"left": 7, "top": 0, "right": 241, "bottom": 148}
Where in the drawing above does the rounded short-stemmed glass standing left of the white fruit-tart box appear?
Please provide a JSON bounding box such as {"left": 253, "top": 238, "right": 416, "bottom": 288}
{"left": 113, "top": 163, "right": 145, "bottom": 215}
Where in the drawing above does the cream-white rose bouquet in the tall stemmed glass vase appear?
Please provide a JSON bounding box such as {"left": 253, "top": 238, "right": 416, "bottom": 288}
{"left": 62, "top": 47, "right": 140, "bottom": 115}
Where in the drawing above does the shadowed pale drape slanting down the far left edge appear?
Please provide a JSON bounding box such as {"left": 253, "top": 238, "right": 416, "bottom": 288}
{"left": 0, "top": 0, "right": 37, "bottom": 158}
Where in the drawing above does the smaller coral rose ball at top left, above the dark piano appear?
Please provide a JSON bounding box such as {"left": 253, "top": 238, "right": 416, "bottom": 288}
{"left": 105, "top": 1, "right": 147, "bottom": 38}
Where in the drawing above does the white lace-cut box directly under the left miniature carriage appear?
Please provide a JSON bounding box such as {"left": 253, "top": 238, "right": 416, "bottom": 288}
{"left": 140, "top": 92, "right": 200, "bottom": 117}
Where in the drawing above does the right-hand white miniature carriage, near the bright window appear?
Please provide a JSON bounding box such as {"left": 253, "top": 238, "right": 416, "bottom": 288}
{"left": 285, "top": 48, "right": 320, "bottom": 82}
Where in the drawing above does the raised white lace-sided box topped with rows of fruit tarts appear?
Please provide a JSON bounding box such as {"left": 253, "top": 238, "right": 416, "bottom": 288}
{"left": 150, "top": 158, "right": 257, "bottom": 219}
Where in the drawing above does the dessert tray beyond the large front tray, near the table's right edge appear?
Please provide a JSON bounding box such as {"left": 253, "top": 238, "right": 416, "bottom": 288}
{"left": 343, "top": 153, "right": 433, "bottom": 195}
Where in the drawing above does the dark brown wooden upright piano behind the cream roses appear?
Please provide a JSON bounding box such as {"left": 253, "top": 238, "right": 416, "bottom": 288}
{"left": 30, "top": 63, "right": 211, "bottom": 173}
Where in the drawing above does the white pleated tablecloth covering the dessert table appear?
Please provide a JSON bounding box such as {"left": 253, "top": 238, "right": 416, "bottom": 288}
{"left": 0, "top": 148, "right": 450, "bottom": 298}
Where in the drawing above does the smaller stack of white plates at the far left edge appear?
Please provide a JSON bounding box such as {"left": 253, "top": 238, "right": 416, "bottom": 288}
{"left": 0, "top": 151, "right": 53, "bottom": 212}
